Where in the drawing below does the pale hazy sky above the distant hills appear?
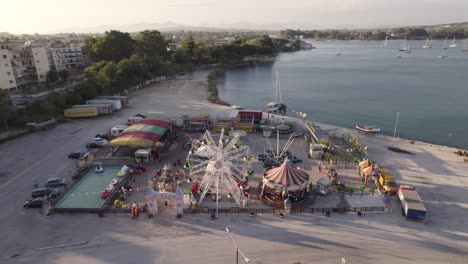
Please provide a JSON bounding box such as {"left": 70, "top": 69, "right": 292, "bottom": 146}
{"left": 0, "top": 0, "right": 468, "bottom": 33}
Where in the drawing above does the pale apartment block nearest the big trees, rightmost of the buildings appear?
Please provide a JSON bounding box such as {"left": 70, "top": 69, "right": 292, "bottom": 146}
{"left": 50, "top": 47, "right": 84, "bottom": 70}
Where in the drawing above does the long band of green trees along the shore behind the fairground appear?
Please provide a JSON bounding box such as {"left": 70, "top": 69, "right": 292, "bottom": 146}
{"left": 0, "top": 30, "right": 284, "bottom": 130}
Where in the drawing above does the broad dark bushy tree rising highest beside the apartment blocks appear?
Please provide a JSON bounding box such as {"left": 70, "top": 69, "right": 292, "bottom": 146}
{"left": 89, "top": 30, "right": 135, "bottom": 62}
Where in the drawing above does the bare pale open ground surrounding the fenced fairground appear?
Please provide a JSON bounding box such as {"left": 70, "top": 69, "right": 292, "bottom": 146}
{"left": 0, "top": 71, "right": 468, "bottom": 264}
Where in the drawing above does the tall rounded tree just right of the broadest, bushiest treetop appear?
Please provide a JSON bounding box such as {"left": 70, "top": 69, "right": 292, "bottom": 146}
{"left": 135, "top": 30, "right": 167, "bottom": 72}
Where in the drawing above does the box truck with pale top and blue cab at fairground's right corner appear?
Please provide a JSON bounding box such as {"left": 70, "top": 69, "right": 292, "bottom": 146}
{"left": 398, "top": 188, "right": 426, "bottom": 221}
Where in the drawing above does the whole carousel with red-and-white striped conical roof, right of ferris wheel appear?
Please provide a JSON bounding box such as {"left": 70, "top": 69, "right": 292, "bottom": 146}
{"left": 260, "top": 159, "right": 309, "bottom": 205}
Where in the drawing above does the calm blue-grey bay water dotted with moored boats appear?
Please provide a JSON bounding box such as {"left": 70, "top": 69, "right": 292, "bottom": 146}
{"left": 218, "top": 40, "right": 468, "bottom": 149}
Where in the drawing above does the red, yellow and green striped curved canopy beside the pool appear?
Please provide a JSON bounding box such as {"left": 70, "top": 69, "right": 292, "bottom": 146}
{"left": 110, "top": 118, "right": 171, "bottom": 148}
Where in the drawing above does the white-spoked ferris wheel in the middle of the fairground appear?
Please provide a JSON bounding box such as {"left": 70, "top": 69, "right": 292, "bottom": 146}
{"left": 186, "top": 129, "right": 251, "bottom": 206}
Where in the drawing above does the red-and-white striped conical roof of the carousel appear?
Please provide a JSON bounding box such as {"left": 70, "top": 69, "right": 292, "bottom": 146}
{"left": 263, "top": 160, "right": 309, "bottom": 187}
